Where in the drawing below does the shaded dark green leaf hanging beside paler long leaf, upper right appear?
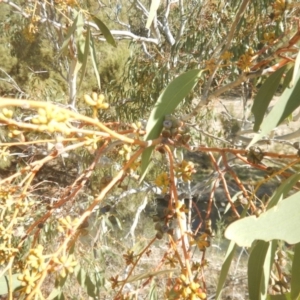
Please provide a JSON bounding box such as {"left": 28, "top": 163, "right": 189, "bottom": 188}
{"left": 251, "top": 67, "right": 286, "bottom": 132}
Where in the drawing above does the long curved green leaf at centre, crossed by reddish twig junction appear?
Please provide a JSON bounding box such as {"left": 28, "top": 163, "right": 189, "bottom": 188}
{"left": 140, "top": 70, "right": 204, "bottom": 182}
